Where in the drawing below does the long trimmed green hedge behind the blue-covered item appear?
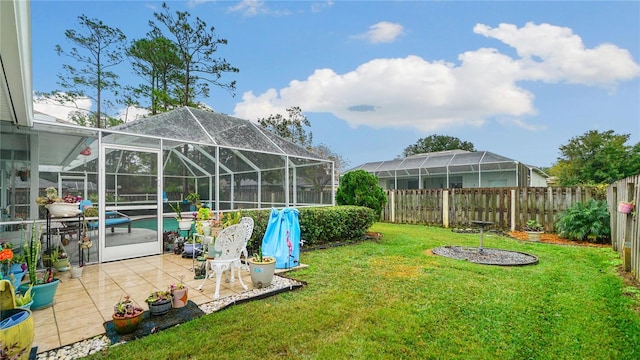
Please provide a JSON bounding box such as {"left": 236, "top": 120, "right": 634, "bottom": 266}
{"left": 240, "top": 205, "right": 375, "bottom": 254}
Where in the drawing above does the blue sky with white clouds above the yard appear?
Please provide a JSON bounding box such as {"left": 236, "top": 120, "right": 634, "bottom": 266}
{"left": 31, "top": 0, "right": 640, "bottom": 168}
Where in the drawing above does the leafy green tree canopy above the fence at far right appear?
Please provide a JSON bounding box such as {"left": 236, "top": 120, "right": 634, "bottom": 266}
{"left": 549, "top": 130, "right": 640, "bottom": 186}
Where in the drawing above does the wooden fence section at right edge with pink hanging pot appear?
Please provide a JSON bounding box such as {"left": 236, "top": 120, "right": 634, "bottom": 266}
{"left": 607, "top": 174, "right": 640, "bottom": 280}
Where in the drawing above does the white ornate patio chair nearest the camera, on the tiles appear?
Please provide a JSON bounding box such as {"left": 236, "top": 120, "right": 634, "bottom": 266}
{"left": 198, "top": 224, "right": 247, "bottom": 299}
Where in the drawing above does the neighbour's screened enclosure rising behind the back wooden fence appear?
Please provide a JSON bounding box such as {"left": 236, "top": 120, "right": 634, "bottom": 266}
{"left": 352, "top": 150, "right": 547, "bottom": 189}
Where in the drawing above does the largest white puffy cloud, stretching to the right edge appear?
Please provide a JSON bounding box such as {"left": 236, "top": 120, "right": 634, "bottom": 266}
{"left": 234, "top": 24, "right": 640, "bottom": 131}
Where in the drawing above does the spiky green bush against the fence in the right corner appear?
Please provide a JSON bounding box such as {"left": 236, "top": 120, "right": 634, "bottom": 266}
{"left": 555, "top": 199, "right": 611, "bottom": 243}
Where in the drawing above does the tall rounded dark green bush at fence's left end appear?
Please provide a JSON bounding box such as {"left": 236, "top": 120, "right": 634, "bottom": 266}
{"left": 336, "top": 170, "right": 387, "bottom": 219}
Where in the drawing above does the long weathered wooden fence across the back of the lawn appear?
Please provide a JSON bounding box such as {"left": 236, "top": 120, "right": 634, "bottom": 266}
{"left": 382, "top": 187, "right": 605, "bottom": 232}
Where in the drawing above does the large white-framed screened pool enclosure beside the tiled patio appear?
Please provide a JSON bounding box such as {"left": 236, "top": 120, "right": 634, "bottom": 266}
{"left": 0, "top": 107, "right": 334, "bottom": 261}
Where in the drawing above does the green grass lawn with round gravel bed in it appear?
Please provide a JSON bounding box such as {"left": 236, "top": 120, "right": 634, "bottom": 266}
{"left": 89, "top": 223, "right": 640, "bottom": 359}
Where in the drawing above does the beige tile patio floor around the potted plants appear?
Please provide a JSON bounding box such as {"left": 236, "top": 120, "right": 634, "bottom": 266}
{"left": 33, "top": 254, "right": 260, "bottom": 353}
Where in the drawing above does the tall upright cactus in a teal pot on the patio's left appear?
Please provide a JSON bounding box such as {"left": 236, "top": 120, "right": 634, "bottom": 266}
{"left": 19, "top": 221, "right": 60, "bottom": 310}
